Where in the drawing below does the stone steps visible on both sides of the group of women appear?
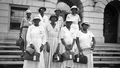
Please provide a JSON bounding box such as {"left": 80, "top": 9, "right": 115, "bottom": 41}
{"left": 0, "top": 40, "right": 120, "bottom": 68}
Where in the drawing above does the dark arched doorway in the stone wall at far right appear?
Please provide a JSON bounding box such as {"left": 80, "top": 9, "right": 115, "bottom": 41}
{"left": 103, "top": 2, "right": 119, "bottom": 43}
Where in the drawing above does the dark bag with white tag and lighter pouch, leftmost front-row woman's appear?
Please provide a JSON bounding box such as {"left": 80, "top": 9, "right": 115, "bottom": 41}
{"left": 24, "top": 46, "right": 40, "bottom": 61}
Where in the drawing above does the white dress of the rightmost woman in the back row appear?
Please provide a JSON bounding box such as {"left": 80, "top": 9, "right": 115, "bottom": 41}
{"left": 66, "top": 14, "right": 81, "bottom": 31}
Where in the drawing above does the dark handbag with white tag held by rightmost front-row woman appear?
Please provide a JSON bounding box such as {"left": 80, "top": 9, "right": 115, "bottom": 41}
{"left": 73, "top": 53, "right": 88, "bottom": 64}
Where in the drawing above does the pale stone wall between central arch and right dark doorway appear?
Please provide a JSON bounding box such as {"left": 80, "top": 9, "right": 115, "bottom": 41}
{"left": 80, "top": 0, "right": 113, "bottom": 43}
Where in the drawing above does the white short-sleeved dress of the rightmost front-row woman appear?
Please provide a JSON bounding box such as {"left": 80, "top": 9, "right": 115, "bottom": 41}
{"left": 75, "top": 31, "right": 95, "bottom": 68}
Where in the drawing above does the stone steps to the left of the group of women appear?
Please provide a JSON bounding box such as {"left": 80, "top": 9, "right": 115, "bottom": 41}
{"left": 0, "top": 40, "right": 23, "bottom": 68}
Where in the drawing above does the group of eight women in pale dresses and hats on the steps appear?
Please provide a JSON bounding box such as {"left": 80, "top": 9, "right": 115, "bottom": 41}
{"left": 21, "top": 6, "right": 95, "bottom": 68}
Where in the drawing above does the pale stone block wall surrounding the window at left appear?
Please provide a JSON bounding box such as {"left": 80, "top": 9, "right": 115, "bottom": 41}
{"left": 0, "top": 0, "right": 56, "bottom": 40}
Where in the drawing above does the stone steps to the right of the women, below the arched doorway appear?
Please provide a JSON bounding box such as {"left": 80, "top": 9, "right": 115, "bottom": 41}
{"left": 93, "top": 43, "right": 120, "bottom": 68}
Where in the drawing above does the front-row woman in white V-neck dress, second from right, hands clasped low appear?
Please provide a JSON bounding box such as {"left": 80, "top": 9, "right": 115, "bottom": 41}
{"left": 61, "top": 21, "right": 76, "bottom": 68}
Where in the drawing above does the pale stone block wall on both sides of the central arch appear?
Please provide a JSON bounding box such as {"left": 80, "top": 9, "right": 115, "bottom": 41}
{"left": 0, "top": 0, "right": 115, "bottom": 43}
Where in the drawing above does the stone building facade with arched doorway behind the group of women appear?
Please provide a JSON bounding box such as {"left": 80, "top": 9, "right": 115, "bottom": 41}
{"left": 0, "top": 0, "right": 120, "bottom": 43}
